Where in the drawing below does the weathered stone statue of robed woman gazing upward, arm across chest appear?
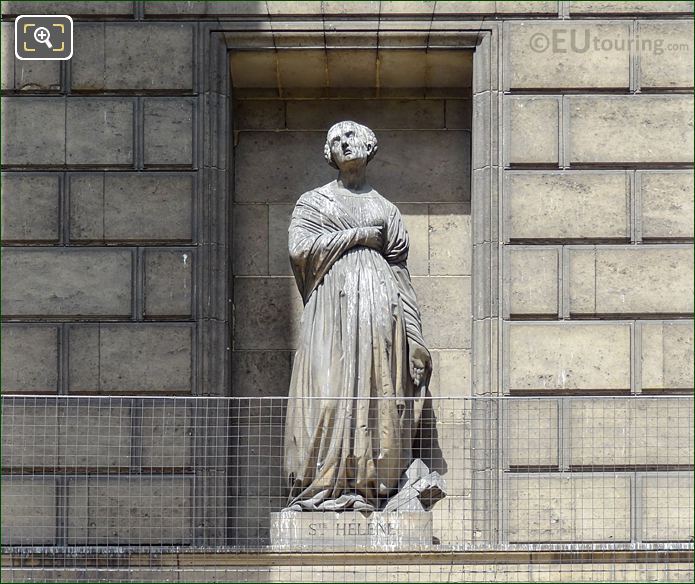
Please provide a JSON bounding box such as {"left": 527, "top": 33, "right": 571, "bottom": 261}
{"left": 284, "top": 122, "right": 436, "bottom": 511}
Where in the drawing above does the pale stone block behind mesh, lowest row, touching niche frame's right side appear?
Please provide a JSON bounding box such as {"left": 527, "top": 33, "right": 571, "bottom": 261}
{"left": 505, "top": 474, "right": 630, "bottom": 543}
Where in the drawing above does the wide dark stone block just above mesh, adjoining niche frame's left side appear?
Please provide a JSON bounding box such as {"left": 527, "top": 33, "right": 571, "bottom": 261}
{"left": 69, "top": 324, "right": 192, "bottom": 394}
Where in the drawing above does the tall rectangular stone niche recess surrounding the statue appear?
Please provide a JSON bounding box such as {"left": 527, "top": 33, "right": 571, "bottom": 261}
{"left": 230, "top": 47, "right": 473, "bottom": 546}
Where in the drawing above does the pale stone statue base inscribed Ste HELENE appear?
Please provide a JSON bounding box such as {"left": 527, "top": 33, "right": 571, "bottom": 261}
{"left": 270, "top": 511, "right": 432, "bottom": 552}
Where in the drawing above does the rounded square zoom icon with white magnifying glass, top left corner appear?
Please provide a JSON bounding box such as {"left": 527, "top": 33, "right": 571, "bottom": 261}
{"left": 14, "top": 14, "right": 72, "bottom": 61}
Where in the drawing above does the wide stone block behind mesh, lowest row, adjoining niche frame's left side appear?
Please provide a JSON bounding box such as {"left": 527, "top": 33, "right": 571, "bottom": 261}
{"left": 67, "top": 476, "right": 193, "bottom": 545}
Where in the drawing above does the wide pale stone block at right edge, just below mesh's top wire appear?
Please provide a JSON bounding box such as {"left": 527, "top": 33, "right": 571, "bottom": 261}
{"left": 569, "top": 397, "right": 693, "bottom": 467}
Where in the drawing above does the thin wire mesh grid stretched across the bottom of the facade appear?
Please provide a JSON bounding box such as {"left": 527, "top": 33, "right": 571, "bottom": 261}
{"left": 2, "top": 396, "right": 693, "bottom": 582}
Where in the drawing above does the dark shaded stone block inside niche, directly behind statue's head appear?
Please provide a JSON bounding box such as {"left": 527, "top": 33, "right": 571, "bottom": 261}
{"left": 234, "top": 130, "right": 470, "bottom": 203}
